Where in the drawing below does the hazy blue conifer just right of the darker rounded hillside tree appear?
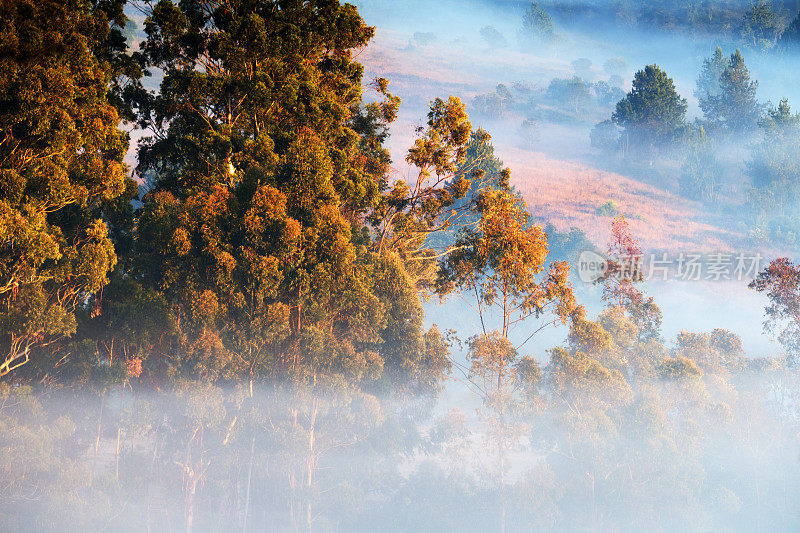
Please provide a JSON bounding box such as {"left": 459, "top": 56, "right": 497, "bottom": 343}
{"left": 701, "top": 50, "right": 761, "bottom": 134}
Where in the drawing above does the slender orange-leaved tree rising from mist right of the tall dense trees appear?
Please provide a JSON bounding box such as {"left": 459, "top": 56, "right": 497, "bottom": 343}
{"left": 437, "top": 186, "right": 583, "bottom": 530}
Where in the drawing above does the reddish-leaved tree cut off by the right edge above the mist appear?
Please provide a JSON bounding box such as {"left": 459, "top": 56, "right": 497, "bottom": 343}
{"left": 748, "top": 257, "right": 800, "bottom": 365}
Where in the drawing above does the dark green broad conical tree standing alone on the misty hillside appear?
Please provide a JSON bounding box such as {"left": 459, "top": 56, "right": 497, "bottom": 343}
{"left": 611, "top": 65, "right": 687, "bottom": 151}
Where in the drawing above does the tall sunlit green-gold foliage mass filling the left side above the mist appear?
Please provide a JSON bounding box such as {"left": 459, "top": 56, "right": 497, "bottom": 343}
{"left": 6, "top": 0, "right": 460, "bottom": 391}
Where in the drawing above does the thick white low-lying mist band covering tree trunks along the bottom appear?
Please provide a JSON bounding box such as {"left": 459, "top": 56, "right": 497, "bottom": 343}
{"left": 0, "top": 364, "right": 800, "bottom": 531}
